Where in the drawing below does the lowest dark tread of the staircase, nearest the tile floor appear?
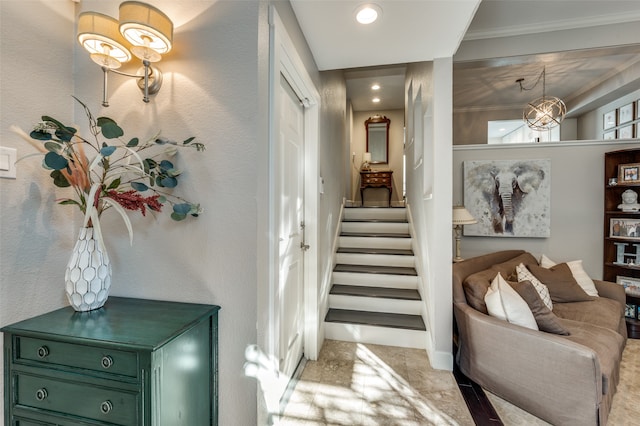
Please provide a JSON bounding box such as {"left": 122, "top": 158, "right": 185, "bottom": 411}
{"left": 324, "top": 309, "right": 427, "bottom": 331}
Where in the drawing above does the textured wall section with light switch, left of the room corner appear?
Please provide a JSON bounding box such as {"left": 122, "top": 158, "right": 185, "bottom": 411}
{"left": 0, "top": 0, "right": 77, "bottom": 418}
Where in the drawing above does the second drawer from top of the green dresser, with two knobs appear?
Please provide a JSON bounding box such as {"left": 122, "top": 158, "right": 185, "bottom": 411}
{"left": 14, "top": 374, "right": 140, "bottom": 426}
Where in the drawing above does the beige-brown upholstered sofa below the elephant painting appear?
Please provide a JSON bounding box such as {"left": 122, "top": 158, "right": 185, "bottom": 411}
{"left": 453, "top": 250, "right": 627, "bottom": 426}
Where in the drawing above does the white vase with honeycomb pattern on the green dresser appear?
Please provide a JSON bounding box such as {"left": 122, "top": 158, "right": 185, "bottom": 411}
{"left": 64, "top": 227, "right": 111, "bottom": 312}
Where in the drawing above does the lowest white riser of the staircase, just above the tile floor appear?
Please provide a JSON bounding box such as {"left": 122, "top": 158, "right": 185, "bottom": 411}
{"left": 324, "top": 322, "right": 426, "bottom": 349}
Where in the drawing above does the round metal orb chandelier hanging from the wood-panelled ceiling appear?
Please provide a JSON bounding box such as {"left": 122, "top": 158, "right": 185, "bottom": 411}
{"left": 516, "top": 67, "right": 567, "bottom": 131}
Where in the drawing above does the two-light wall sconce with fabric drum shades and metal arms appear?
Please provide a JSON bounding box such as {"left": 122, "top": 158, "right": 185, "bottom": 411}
{"left": 78, "top": 1, "right": 173, "bottom": 107}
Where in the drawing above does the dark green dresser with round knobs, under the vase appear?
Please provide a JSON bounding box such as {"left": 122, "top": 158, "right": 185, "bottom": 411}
{"left": 1, "top": 297, "right": 220, "bottom": 426}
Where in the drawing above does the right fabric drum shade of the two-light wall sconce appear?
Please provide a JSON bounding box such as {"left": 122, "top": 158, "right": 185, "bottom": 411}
{"left": 120, "top": 1, "right": 173, "bottom": 62}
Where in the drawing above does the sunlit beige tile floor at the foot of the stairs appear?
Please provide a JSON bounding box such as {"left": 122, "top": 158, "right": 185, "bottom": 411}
{"left": 278, "top": 340, "right": 474, "bottom": 426}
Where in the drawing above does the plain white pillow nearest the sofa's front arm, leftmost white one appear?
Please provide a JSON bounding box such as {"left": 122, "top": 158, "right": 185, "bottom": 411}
{"left": 484, "top": 273, "right": 538, "bottom": 330}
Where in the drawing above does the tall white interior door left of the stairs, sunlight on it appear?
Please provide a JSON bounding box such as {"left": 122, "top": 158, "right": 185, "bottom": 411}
{"left": 277, "top": 76, "right": 305, "bottom": 377}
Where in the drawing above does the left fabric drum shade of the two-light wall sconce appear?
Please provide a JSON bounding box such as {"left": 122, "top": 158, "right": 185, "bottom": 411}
{"left": 78, "top": 12, "right": 131, "bottom": 69}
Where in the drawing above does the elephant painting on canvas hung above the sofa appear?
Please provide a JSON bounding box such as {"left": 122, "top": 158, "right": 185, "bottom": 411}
{"left": 464, "top": 160, "right": 551, "bottom": 237}
